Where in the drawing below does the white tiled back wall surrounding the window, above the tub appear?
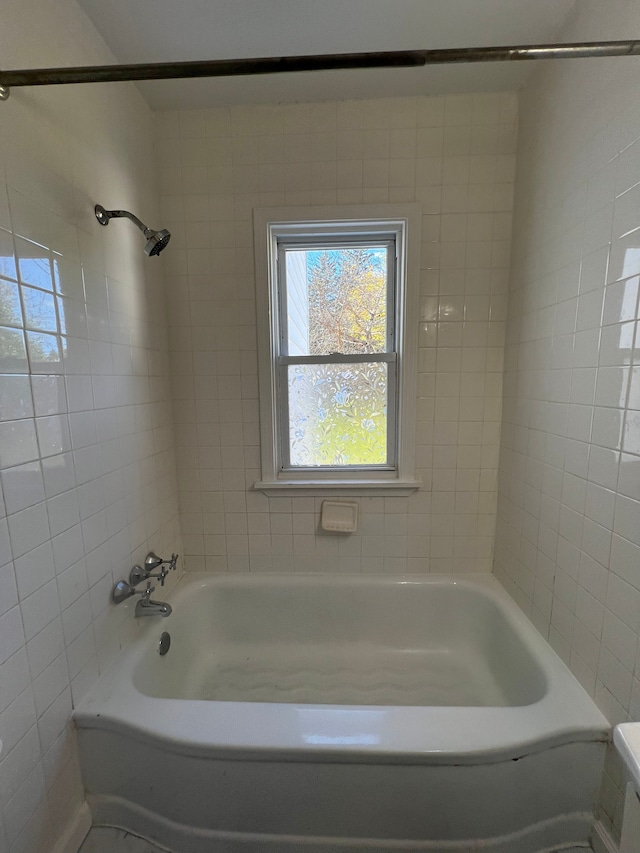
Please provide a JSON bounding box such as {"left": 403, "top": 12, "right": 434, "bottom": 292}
{"left": 157, "top": 95, "right": 516, "bottom": 572}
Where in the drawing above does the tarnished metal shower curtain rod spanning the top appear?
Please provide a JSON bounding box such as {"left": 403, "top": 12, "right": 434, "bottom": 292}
{"left": 0, "top": 39, "right": 640, "bottom": 100}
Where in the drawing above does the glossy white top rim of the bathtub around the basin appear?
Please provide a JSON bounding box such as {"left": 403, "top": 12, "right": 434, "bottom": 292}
{"left": 73, "top": 572, "right": 610, "bottom": 765}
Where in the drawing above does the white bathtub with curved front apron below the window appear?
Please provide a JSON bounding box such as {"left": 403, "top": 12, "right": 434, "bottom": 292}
{"left": 75, "top": 575, "right": 609, "bottom": 853}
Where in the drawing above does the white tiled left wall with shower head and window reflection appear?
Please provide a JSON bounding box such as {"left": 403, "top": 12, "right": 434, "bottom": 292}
{"left": 0, "top": 0, "right": 181, "bottom": 853}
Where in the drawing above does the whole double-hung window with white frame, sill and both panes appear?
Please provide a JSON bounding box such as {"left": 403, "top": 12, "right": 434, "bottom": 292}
{"left": 254, "top": 205, "right": 420, "bottom": 494}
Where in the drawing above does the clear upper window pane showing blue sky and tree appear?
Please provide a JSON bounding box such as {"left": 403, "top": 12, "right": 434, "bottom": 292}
{"left": 286, "top": 246, "right": 389, "bottom": 355}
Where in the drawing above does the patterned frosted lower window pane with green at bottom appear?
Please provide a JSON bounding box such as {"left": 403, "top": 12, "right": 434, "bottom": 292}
{"left": 288, "top": 363, "right": 388, "bottom": 467}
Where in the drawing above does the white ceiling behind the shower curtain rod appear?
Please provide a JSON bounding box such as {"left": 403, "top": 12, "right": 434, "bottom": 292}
{"left": 78, "top": 0, "right": 576, "bottom": 110}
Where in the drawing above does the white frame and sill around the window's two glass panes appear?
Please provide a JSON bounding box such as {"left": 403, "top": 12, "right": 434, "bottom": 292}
{"left": 254, "top": 204, "right": 421, "bottom": 495}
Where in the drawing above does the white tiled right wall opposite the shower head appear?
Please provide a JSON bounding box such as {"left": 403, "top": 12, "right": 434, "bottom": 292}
{"left": 495, "top": 0, "right": 640, "bottom": 830}
